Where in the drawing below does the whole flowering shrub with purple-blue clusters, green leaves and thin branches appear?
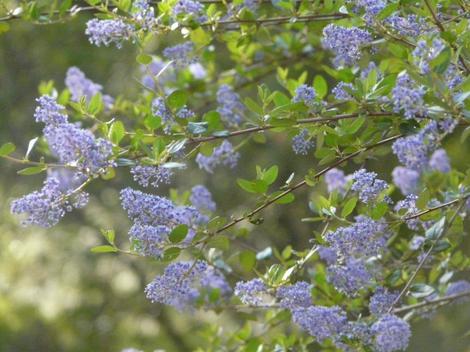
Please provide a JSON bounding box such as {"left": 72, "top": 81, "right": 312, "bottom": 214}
{"left": 0, "top": 0, "right": 470, "bottom": 352}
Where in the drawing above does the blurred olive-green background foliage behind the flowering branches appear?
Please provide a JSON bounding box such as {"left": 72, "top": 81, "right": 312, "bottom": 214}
{"left": 0, "top": 0, "right": 470, "bottom": 352}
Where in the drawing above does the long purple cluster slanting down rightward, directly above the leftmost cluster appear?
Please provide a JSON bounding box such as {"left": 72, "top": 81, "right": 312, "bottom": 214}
{"left": 34, "top": 96, "right": 113, "bottom": 174}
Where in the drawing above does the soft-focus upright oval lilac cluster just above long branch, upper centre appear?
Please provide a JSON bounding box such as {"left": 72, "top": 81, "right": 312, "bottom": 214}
{"left": 217, "top": 84, "right": 245, "bottom": 126}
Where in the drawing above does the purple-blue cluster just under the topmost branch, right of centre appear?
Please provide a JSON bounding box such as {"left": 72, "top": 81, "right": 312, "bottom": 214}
{"left": 322, "top": 24, "right": 372, "bottom": 66}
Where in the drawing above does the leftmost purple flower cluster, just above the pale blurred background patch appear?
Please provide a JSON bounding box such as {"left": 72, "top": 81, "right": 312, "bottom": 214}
{"left": 11, "top": 169, "right": 88, "bottom": 227}
